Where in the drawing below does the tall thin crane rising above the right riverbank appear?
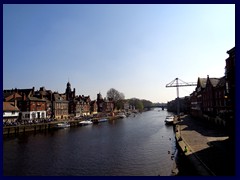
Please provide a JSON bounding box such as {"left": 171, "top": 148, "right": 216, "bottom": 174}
{"left": 166, "top": 78, "right": 197, "bottom": 115}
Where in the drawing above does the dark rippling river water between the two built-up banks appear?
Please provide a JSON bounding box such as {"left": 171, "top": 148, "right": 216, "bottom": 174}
{"left": 3, "top": 108, "right": 176, "bottom": 176}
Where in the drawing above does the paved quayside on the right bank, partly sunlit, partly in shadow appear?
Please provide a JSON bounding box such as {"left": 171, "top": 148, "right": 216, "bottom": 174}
{"left": 175, "top": 115, "right": 235, "bottom": 176}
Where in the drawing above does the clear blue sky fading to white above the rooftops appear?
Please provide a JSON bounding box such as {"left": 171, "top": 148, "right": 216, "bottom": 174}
{"left": 3, "top": 4, "right": 235, "bottom": 102}
